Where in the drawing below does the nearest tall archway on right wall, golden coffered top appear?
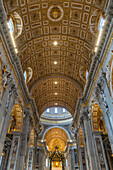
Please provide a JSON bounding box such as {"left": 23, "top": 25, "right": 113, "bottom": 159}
{"left": 91, "top": 101, "right": 113, "bottom": 169}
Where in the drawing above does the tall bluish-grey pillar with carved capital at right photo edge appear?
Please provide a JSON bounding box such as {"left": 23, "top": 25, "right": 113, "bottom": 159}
{"left": 94, "top": 73, "right": 113, "bottom": 154}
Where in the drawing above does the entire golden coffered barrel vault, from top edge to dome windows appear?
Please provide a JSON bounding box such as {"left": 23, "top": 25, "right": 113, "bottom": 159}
{"left": 3, "top": 0, "right": 107, "bottom": 115}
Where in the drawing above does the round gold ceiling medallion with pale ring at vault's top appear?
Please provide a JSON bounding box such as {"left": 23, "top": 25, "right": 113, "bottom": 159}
{"left": 47, "top": 5, "right": 64, "bottom": 21}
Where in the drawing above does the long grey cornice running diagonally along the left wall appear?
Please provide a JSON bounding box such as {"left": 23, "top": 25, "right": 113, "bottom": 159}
{"left": 0, "top": 0, "right": 39, "bottom": 126}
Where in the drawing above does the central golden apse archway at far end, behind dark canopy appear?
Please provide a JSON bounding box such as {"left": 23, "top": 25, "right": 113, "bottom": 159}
{"left": 43, "top": 126, "right": 69, "bottom": 170}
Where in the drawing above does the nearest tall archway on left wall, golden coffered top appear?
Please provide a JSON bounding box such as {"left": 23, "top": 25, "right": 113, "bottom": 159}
{"left": 0, "top": 104, "right": 23, "bottom": 169}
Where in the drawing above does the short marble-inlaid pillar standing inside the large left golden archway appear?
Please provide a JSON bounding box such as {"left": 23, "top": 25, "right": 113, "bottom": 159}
{"left": 8, "top": 131, "right": 21, "bottom": 170}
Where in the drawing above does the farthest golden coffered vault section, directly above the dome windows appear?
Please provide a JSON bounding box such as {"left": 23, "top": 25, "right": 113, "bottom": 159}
{"left": 32, "top": 78, "right": 81, "bottom": 114}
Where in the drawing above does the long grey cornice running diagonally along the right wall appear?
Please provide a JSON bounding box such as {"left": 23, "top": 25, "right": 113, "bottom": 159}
{"left": 73, "top": 0, "right": 113, "bottom": 126}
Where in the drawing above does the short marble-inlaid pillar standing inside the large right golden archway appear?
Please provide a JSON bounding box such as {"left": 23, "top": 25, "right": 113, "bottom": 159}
{"left": 93, "top": 131, "right": 109, "bottom": 170}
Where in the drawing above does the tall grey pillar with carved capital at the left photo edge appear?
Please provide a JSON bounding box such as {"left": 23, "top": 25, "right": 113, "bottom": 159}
{"left": 0, "top": 67, "right": 18, "bottom": 157}
